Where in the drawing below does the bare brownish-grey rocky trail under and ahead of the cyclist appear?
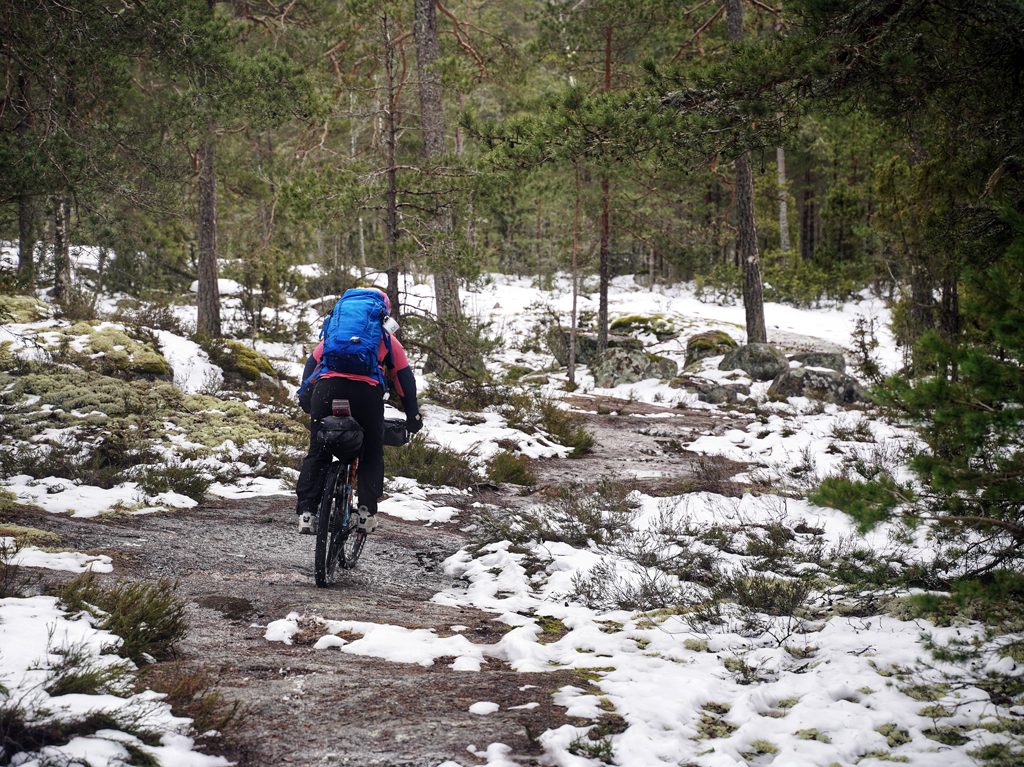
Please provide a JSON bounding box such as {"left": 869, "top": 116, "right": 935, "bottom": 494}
{"left": 0, "top": 398, "right": 737, "bottom": 767}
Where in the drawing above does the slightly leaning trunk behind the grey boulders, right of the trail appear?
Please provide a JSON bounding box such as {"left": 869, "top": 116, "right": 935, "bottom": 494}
{"left": 725, "top": 0, "right": 768, "bottom": 343}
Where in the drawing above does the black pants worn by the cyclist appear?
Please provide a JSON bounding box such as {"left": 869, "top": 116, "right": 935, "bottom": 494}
{"left": 295, "top": 378, "right": 384, "bottom": 514}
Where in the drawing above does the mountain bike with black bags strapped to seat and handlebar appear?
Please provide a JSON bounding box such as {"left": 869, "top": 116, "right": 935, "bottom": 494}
{"left": 313, "top": 399, "right": 409, "bottom": 588}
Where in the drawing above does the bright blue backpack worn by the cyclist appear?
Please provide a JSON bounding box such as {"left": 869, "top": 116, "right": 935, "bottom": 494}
{"left": 297, "top": 288, "right": 391, "bottom": 397}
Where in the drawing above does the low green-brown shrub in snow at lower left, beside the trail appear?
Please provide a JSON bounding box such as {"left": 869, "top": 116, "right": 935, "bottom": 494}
{"left": 56, "top": 572, "right": 188, "bottom": 666}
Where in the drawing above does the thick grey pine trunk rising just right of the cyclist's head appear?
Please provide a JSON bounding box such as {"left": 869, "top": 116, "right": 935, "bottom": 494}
{"left": 413, "top": 0, "right": 462, "bottom": 327}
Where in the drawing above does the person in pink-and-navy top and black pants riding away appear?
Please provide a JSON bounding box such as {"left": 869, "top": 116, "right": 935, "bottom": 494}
{"left": 295, "top": 288, "right": 423, "bottom": 535}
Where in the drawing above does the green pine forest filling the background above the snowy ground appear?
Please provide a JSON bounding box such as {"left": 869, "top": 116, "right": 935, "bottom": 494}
{"left": 0, "top": 0, "right": 1024, "bottom": 560}
